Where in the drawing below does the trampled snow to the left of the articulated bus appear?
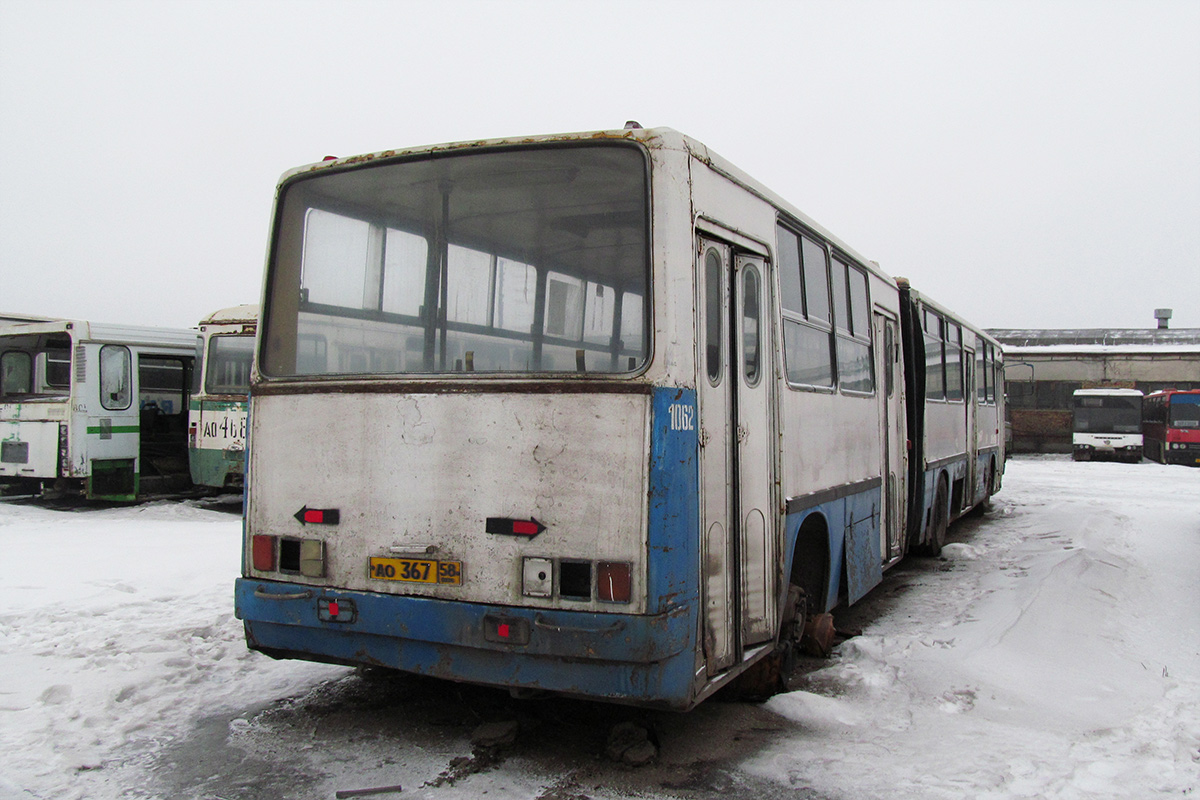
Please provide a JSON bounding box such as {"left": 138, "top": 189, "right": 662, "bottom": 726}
{"left": 0, "top": 503, "right": 344, "bottom": 800}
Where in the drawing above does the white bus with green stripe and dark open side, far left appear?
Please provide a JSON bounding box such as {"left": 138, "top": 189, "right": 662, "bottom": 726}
{"left": 0, "top": 319, "right": 197, "bottom": 500}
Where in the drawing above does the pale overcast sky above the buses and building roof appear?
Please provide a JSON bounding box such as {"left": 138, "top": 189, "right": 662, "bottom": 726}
{"left": 0, "top": 0, "right": 1200, "bottom": 327}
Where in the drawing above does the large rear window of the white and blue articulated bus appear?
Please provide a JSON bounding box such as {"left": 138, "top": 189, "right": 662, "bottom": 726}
{"left": 262, "top": 143, "right": 649, "bottom": 377}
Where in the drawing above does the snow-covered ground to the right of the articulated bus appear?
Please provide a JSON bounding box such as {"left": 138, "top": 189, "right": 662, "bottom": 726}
{"left": 750, "top": 459, "right": 1200, "bottom": 799}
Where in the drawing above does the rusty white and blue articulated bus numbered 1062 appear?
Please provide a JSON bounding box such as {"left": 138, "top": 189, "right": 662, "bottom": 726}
{"left": 235, "top": 126, "right": 1003, "bottom": 709}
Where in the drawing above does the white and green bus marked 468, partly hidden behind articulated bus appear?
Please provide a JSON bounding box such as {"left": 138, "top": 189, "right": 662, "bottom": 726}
{"left": 187, "top": 305, "right": 258, "bottom": 489}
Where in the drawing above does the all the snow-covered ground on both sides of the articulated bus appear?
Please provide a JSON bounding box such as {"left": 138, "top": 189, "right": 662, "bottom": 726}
{"left": 0, "top": 457, "right": 1200, "bottom": 800}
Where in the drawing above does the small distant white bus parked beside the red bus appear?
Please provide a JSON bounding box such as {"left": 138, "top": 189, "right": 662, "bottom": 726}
{"left": 1072, "top": 387, "right": 1142, "bottom": 463}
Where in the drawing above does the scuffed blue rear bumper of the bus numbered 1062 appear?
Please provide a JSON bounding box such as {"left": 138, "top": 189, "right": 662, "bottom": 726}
{"left": 234, "top": 578, "right": 696, "bottom": 709}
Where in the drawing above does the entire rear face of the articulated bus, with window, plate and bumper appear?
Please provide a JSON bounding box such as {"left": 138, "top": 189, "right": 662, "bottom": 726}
{"left": 236, "top": 136, "right": 710, "bottom": 708}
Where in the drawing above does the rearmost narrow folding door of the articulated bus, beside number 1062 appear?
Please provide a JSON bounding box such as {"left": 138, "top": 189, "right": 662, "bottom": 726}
{"left": 696, "top": 239, "right": 778, "bottom": 675}
